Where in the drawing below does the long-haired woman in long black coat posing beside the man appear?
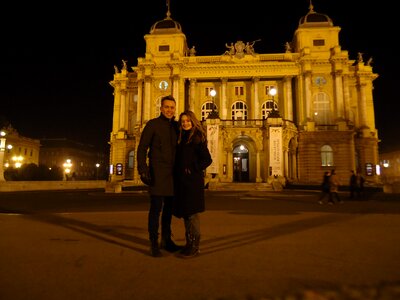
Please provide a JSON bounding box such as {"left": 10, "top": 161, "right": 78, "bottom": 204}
{"left": 173, "top": 110, "right": 212, "bottom": 257}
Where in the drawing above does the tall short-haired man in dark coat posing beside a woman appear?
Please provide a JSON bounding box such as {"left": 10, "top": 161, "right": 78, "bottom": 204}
{"left": 137, "top": 96, "right": 182, "bottom": 257}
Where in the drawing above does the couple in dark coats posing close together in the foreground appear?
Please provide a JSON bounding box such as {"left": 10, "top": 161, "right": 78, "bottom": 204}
{"left": 137, "top": 96, "right": 212, "bottom": 257}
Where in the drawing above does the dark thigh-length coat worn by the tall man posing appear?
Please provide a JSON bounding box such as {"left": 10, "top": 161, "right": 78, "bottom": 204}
{"left": 137, "top": 114, "right": 178, "bottom": 196}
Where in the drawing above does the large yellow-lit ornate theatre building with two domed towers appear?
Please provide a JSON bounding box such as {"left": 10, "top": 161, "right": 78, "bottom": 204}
{"left": 110, "top": 6, "right": 379, "bottom": 186}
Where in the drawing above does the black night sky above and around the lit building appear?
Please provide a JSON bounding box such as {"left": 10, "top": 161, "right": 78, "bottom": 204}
{"left": 0, "top": 0, "right": 400, "bottom": 150}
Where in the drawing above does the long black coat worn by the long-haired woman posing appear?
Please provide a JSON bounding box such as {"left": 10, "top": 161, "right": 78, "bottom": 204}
{"left": 174, "top": 132, "right": 212, "bottom": 218}
